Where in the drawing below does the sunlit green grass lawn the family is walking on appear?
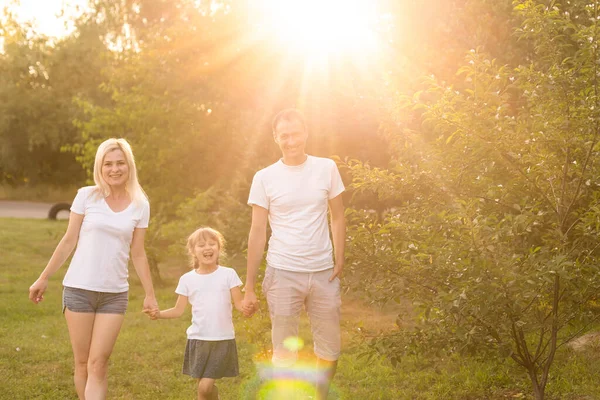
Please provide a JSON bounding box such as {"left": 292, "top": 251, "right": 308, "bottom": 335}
{"left": 0, "top": 219, "right": 600, "bottom": 400}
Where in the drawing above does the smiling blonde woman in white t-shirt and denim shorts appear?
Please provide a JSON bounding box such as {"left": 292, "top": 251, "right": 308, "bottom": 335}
{"left": 29, "top": 139, "right": 158, "bottom": 400}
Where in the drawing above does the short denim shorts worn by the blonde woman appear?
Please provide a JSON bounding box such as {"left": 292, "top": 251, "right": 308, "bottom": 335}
{"left": 63, "top": 286, "right": 129, "bottom": 314}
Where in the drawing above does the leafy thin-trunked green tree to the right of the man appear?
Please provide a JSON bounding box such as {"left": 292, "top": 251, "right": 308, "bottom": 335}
{"left": 348, "top": 0, "right": 600, "bottom": 399}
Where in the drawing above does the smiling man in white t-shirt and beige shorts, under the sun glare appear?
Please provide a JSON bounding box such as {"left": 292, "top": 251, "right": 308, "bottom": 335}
{"left": 244, "top": 109, "right": 346, "bottom": 399}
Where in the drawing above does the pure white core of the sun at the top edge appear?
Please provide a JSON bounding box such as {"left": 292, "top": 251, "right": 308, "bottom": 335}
{"left": 255, "top": 0, "right": 378, "bottom": 57}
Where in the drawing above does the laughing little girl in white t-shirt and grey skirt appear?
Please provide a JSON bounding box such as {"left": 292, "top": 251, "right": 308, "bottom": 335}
{"left": 150, "top": 227, "right": 243, "bottom": 400}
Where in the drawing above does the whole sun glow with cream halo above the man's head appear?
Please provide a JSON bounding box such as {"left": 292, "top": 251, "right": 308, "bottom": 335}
{"left": 234, "top": 0, "right": 395, "bottom": 136}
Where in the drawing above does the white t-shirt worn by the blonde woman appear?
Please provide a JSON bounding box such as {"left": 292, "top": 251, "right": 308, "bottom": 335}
{"left": 63, "top": 186, "right": 150, "bottom": 293}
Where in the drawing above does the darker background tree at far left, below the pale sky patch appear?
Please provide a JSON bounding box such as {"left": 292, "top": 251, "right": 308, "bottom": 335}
{"left": 0, "top": 7, "right": 105, "bottom": 184}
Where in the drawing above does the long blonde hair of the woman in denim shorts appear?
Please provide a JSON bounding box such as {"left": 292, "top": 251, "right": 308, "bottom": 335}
{"left": 94, "top": 138, "right": 148, "bottom": 204}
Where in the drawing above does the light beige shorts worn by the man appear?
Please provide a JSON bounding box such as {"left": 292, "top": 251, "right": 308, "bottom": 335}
{"left": 262, "top": 267, "right": 342, "bottom": 366}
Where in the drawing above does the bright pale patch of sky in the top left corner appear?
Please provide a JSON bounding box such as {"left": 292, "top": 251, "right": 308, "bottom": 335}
{"left": 0, "top": 0, "right": 88, "bottom": 37}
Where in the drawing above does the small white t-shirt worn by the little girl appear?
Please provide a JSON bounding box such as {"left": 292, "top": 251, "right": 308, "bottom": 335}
{"left": 175, "top": 265, "right": 242, "bottom": 340}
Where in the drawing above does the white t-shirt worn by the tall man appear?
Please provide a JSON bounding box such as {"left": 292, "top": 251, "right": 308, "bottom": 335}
{"left": 248, "top": 156, "right": 344, "bottom": 272}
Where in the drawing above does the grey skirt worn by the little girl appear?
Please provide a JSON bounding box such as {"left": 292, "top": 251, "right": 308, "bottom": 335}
{"left": 183, "top": 339, "right": 240, "bottom": 379}
